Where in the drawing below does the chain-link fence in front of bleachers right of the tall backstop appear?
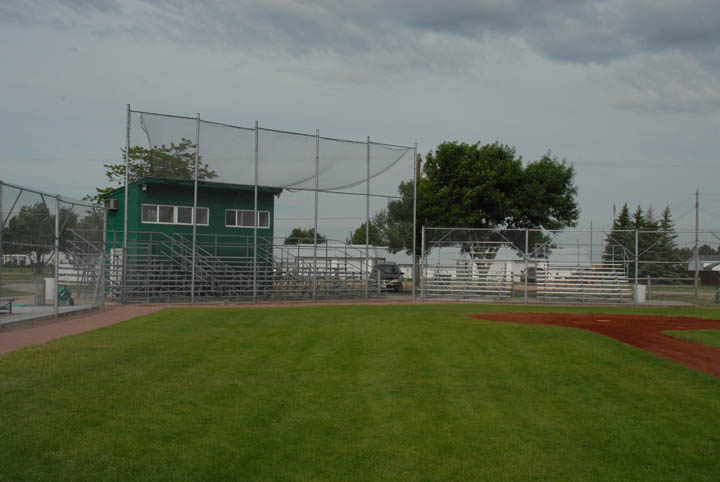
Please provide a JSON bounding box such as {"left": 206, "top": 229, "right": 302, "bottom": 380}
{"left": 420, "top": 227, "right": 720, "bottom": 304}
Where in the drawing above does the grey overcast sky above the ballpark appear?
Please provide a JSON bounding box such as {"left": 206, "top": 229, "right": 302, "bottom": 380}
{"left": 0, "top": 0, "right": 720, "bottom": 241}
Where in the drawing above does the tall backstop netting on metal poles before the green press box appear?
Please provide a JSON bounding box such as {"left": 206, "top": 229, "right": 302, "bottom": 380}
{"left": 107, "top": 110, "right": 415, "bottom": 301}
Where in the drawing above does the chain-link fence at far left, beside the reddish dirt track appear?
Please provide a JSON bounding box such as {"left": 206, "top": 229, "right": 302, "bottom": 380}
{"left": 0, "top": 180, "right": 105, "bottom": 321}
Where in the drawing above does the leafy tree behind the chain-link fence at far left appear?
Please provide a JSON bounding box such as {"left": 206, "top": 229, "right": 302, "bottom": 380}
{"left": 3, "top": 202, "right": 78, "bottom": 274}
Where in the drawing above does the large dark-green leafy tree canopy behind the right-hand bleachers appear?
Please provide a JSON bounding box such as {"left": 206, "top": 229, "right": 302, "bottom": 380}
{"left": 374, "top": 142, "right": 580, "bottom": 253}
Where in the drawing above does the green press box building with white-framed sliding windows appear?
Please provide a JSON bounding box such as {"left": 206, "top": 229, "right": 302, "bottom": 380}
{"left": 105, "top": 177, "right": 282, "bottom": 297}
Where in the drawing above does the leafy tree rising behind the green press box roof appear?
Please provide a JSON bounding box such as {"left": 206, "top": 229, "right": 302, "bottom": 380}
{"left": 88, "top": 138, "right": 217, "bottom": 202}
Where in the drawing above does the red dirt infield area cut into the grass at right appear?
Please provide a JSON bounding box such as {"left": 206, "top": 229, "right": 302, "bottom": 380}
{"left": 471, "top": 313, "right": 720, "bottom": 377}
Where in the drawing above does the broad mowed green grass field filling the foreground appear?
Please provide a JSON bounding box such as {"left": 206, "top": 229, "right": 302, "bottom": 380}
{"left": 0, "top": 305, "right": 720, "bottom": 481}
